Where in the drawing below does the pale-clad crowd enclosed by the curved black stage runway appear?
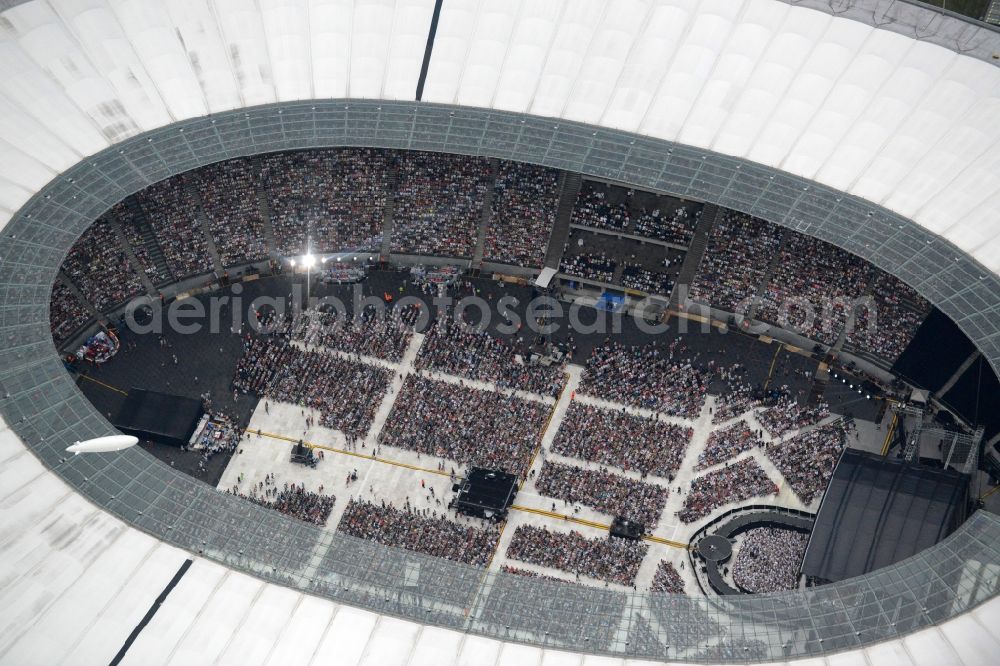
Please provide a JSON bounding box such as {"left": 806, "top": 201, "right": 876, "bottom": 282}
{"left": 732, "top": 527, "right": 809, "bottom": 594}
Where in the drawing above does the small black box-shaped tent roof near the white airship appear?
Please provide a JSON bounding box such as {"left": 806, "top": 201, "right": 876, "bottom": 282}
{"left": 115, "top": 387, "right": 203, "bottom": 446}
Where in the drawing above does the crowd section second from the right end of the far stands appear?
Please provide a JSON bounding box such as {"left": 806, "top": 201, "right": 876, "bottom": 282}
{"left": 757, "top": 233, "right": 870, "bottom": 345}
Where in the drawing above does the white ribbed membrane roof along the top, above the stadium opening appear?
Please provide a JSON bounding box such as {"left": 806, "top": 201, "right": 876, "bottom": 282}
{"left": 0, "top": 0, "right": 1000, "bottom": 271}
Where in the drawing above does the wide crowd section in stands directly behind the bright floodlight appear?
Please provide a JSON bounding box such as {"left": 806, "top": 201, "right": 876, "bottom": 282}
{"left": 261, "top": 148, "right": 390, "bottom": 255}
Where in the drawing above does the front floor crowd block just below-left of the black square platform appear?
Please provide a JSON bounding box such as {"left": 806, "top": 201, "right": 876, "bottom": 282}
{"left": 337, "top": 499, "right": 500, "bottom": 566}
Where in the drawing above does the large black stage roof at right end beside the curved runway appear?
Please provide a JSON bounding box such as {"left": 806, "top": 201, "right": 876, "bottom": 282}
{"left": 802, "top": 449, "right": 969, "bottom": 582}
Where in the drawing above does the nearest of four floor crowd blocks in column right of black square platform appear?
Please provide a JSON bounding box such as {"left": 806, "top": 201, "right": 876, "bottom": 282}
{"left": 507, "top": 525, "right": 649, "bottom": 585}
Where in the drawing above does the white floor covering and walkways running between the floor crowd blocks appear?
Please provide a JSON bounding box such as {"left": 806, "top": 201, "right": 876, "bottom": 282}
{"left": 219, "top": 334, "right": 852, "bottom": 592}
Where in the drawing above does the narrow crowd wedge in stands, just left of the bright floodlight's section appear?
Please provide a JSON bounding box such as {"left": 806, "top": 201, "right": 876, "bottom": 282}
{"left": 190, "top": 157, "right": 267, "bottom": 266}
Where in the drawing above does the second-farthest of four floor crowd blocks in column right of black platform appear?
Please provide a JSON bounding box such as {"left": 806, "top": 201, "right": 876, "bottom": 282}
{"left": 552, "top": 401, "right": 694, "bottom": 480}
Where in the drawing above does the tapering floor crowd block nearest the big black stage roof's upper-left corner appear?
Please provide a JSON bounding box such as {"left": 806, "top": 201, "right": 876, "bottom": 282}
{"left": 765, "top": 421, "right": 850, "bottom": 504}
